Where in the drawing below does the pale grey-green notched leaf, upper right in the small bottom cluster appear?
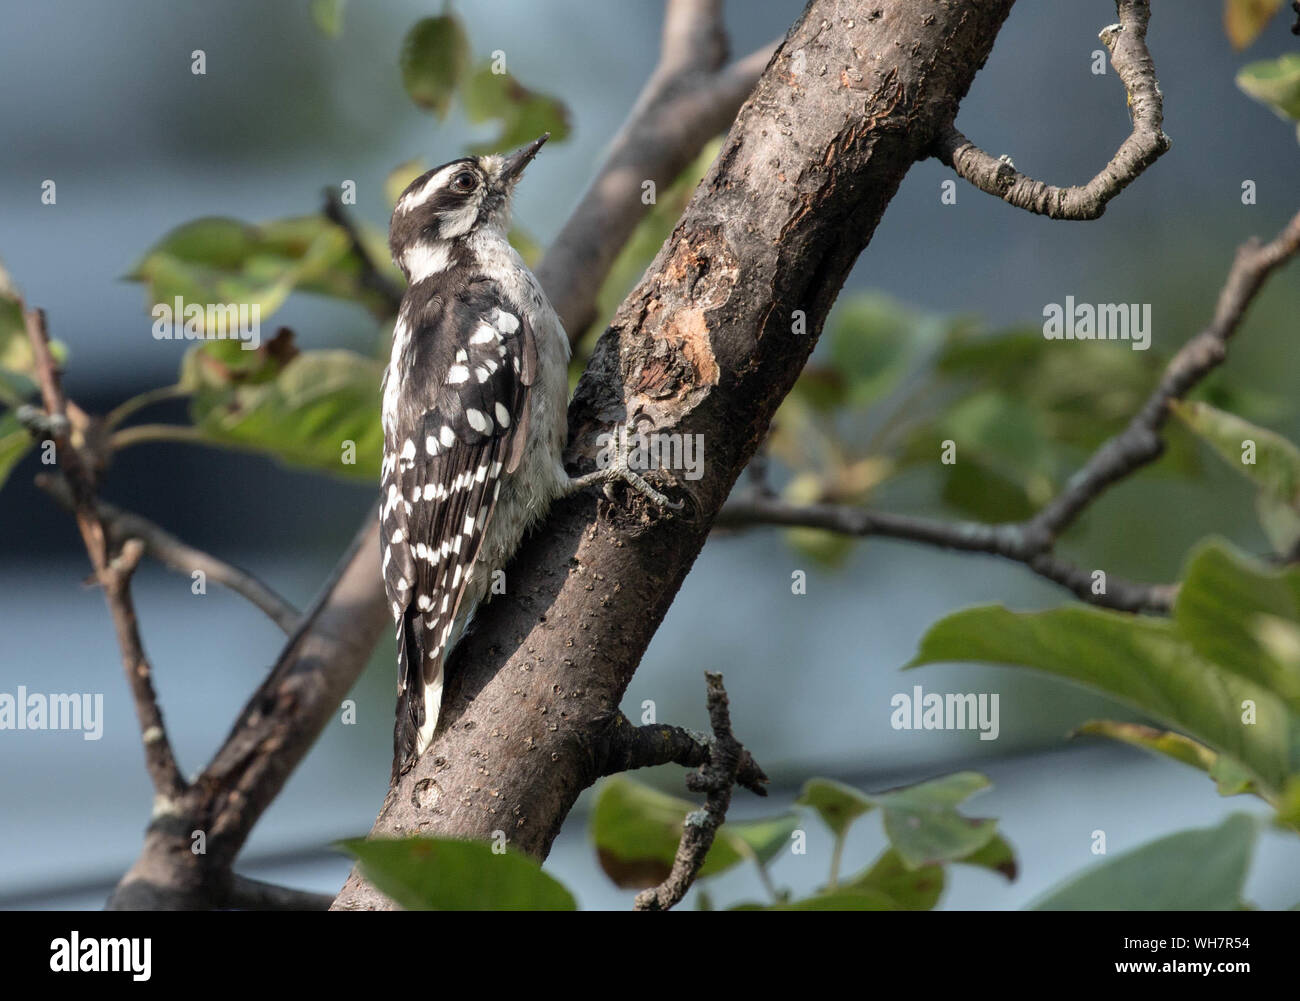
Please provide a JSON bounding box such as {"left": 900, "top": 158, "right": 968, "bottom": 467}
{"left": 871, "top": 772, "right": 997, "bottom": 868}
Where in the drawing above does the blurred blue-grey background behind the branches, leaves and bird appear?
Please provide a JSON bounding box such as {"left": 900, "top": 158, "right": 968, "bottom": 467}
{"left": 0, "top": 0, "right": 1300, "bottom": 907}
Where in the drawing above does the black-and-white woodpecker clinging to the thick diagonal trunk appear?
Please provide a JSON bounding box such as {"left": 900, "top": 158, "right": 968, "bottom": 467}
{"left": 380, "top": 133, "right": 680, "bottom": 774}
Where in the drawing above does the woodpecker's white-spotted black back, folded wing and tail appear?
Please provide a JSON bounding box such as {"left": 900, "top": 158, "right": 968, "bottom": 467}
{"left": 380, "top": 280, "right": 537, "bottom": 767}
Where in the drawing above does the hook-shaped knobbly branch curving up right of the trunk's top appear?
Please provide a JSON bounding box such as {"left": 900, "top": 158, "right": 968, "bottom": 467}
{"left": 935, "top": 0, "right": 1169, "bottom": 220}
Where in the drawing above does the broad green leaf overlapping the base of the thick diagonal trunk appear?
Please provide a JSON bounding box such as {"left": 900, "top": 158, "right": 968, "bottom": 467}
{"left": 339, "top": 837, "right": 577, "bottom": 910}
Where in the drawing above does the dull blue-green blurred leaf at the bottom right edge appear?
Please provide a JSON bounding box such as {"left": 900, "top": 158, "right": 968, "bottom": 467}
{"left": 1031, "top": 814, "right": 1256, "bottom": 911}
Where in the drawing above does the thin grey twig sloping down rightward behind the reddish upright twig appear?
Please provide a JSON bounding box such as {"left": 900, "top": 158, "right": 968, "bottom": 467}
{"left": 36, "top": 475, "right": 302, "bottom": 633}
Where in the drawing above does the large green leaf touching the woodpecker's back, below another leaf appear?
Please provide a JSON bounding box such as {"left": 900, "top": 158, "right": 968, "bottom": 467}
{"left": 191, "top": 345, "right": 384, "bottom": 482}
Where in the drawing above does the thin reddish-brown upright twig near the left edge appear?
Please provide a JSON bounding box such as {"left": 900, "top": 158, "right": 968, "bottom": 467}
{"left": 23, "top": 307, "right": 186, "bottom": 807}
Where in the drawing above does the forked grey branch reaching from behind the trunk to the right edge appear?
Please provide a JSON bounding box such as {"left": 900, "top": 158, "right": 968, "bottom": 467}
{"left": 715, "top": 213, "right": 1300, "bottom": 612}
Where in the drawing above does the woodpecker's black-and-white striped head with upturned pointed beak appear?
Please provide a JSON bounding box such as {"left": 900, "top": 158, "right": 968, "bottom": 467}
{"left": 389, "top": 133, "right": 551, "bottom": 281}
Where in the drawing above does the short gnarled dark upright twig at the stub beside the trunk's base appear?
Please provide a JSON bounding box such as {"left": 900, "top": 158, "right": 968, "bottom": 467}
{"left": 636, "top": 672, "right": 745, "bottom": 910}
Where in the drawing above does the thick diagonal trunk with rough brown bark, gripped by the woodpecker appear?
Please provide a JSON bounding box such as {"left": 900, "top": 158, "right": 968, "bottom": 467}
{"left": 334, "top": 0, "right": 1013, "bottom": 909}
